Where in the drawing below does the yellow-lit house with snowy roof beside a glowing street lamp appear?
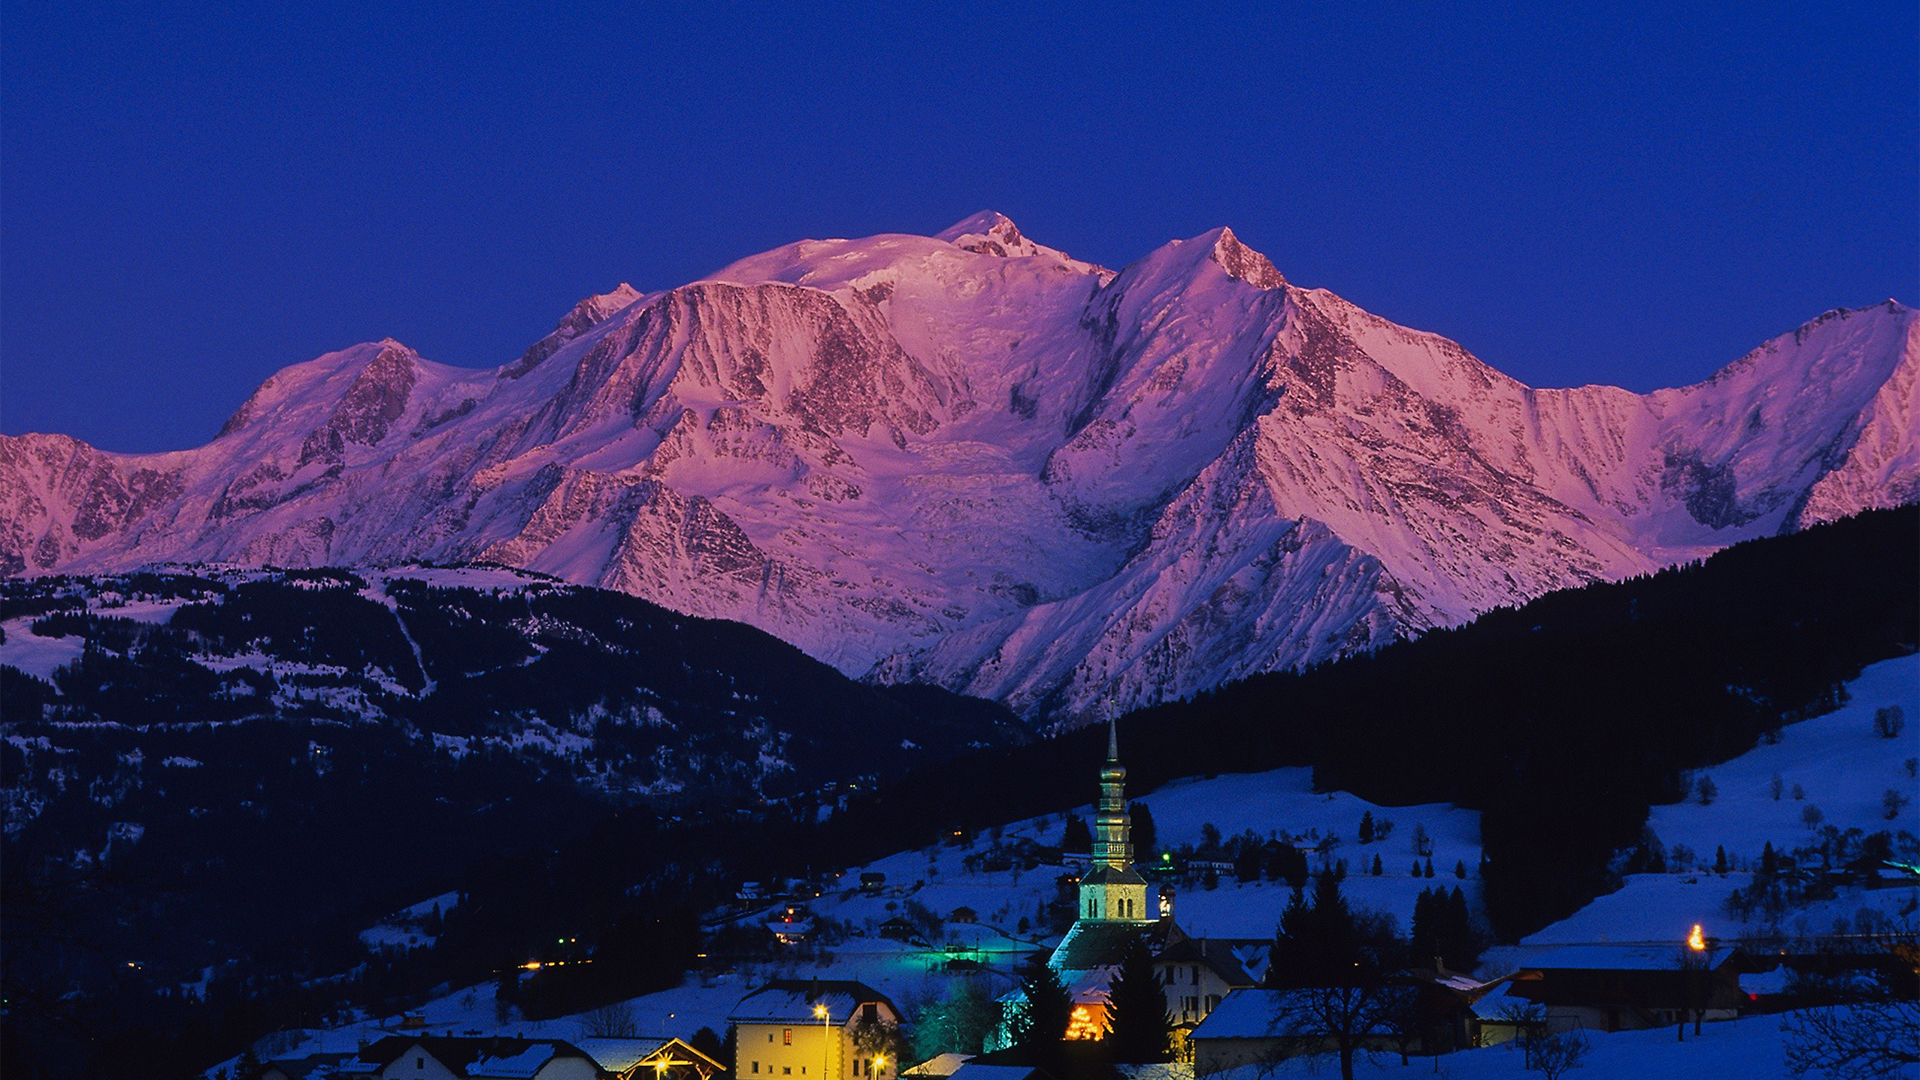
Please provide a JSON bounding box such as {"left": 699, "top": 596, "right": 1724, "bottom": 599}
{"left": 728, "top": 978, "right": 900, "bottom": 1080}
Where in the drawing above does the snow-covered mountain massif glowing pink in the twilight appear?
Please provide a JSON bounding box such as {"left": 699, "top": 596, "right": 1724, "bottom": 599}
{"left": 0, "top": 213, "right": 1920, "bottom": 719}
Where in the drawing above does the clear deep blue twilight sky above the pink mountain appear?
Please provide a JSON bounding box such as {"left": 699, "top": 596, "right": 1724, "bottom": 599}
{"left": 0, "top": 0, "right": 1920, "bottom": 450}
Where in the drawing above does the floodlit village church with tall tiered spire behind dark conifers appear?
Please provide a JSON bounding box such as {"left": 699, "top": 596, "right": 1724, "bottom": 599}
{"left": 1021, "top": 723, "right": 1269, "bottom": 1047}
